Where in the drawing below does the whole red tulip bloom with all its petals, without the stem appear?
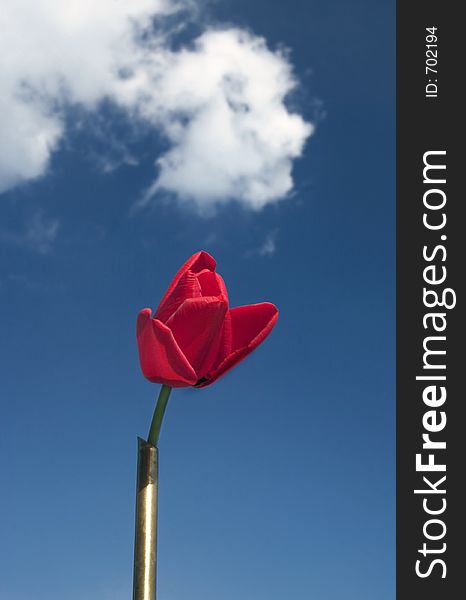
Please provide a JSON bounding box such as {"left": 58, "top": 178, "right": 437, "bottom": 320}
{"left": 137, "top": 252, "right": 278, "bottom": 387}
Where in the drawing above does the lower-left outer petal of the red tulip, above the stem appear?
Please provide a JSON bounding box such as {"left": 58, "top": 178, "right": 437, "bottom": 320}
{"left": 136, "top": 308, "right": 198, "bottom": 387}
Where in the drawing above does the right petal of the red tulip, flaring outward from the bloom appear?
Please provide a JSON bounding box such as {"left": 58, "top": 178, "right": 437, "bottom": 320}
{"left": 197, "top": 302, "right": 278, "bottom": 387}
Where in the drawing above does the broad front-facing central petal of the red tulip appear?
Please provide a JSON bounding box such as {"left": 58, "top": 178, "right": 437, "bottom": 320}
{"left": 167, "top": 296, "right": 228, "bottom": 379}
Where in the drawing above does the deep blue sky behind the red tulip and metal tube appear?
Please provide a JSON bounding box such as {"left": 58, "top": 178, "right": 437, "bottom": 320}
{"left": 0, "top": 0, "right": 395, "bottom": 600}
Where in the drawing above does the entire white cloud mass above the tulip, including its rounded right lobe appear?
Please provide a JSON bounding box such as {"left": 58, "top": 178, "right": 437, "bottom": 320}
{"left": 0, "top": 0, "right": 312, "bottom": 209}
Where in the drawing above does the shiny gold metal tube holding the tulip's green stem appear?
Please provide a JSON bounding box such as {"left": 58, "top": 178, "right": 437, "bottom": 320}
{"left": 133, "top": 438, "right": 159, "bottom": 600}
